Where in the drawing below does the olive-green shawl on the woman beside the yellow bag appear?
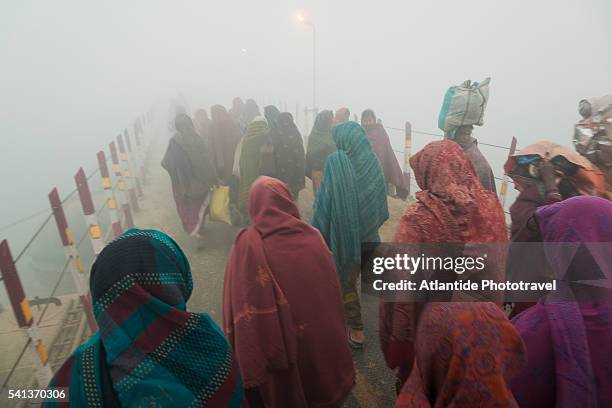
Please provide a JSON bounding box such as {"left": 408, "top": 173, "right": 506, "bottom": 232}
{"left": 238, "top": 116, "right": 272, "bottom": 213}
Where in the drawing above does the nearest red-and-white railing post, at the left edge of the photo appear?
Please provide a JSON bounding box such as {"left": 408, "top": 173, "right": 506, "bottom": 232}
{"left": 0, "top": 240, "right": 53, "bottom": 388}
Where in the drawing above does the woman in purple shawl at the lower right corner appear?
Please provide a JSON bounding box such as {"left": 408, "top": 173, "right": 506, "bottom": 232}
{"left": 512, "top": 196, "right": 612, "bottom": 407}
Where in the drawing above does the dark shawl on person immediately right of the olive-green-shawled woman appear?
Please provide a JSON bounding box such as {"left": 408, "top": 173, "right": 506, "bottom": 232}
{"left": 271, "top": 112, "right": 305, "bottom": 199}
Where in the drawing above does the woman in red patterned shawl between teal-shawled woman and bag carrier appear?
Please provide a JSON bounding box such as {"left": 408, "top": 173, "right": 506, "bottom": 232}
{"left": 379, "top": 140, "right": 507, "bottom": 383}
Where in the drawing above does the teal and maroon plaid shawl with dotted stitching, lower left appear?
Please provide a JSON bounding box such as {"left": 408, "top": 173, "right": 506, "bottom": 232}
{"left": 46, "top": 230, "right": 243, "bottom": 407}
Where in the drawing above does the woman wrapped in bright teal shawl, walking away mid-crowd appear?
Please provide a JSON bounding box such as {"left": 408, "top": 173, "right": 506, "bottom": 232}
{"left": 312, "top": 122, "right": 389, "bottom": 347}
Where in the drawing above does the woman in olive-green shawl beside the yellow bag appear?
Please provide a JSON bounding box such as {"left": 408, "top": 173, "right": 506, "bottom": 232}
{"left": 238, "top": 116, "right": 275, "bottom": 216}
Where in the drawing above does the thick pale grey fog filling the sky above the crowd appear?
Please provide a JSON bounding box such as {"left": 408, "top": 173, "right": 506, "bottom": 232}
{"left": 0, "top": 0, "right": 612, "bottom": 242}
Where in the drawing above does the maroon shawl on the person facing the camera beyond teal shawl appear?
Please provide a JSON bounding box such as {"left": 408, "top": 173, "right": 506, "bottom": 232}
{"left": 364, "top": 119, "right": 410, "bottom": 192}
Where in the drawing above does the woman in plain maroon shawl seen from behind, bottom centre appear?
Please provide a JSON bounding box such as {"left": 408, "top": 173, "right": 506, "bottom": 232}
{"left": 223, "top": 177, "right": 355, "bottom": 407}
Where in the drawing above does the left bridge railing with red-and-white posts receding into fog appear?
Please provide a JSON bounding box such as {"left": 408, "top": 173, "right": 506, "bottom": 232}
{"left": 0, "top": 112, "right": 154, "bottom": 394}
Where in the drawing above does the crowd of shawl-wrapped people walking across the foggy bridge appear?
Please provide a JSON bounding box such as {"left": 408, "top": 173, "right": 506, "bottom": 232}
{"left": 48, "top": 93, "right": 612, "bottom": 407}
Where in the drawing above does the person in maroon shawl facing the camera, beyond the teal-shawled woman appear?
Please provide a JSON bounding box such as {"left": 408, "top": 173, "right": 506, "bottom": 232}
{"left": 361, "top": 109, "right": 409, "bottom": 198}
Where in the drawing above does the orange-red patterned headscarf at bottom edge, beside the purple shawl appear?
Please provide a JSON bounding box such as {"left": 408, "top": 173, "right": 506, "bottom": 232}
{"left": 395, "top": 302, "right": 526, "bottom": 408}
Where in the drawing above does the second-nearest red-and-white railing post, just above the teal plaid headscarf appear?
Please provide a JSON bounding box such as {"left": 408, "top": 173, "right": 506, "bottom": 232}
{"left": 49, "top": 188, "right": 98, "bottom": 333}
